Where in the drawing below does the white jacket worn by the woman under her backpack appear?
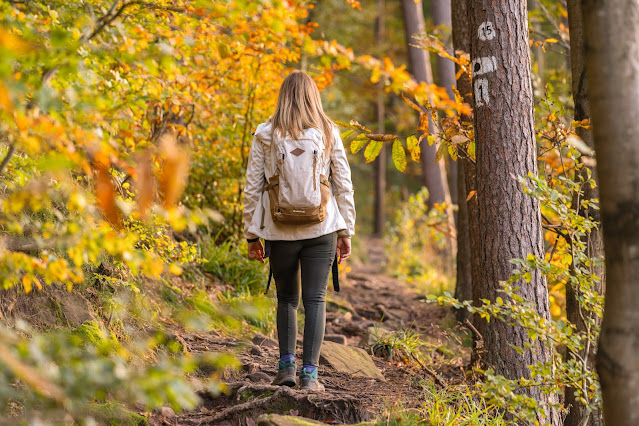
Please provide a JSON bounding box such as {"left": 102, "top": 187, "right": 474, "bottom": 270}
{"left": 244, "top": 122, "right": 355, "bottom": 241}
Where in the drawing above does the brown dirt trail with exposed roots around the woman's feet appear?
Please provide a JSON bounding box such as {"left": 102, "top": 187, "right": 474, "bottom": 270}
{"left": 149, "top": 239, "right": 469, "bottom": 426}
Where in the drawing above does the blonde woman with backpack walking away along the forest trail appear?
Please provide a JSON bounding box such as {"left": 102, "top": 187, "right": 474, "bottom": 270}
{"left": 244, "top": 71, "right": 355, "bottom": 391}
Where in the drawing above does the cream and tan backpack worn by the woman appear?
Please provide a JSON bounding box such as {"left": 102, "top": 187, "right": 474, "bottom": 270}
{"left": 264, "top": 129, "right": 331, "bottom": 225}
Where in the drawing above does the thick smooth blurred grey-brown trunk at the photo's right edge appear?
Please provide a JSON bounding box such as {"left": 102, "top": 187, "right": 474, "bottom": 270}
{"left": 582, "top": 0, "right": 639, "bottom": 426}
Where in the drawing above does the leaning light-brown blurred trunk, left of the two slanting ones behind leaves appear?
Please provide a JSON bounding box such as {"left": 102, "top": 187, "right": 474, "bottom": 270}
{"left": 402, "top": 0, "right": 450, "bottom": 207}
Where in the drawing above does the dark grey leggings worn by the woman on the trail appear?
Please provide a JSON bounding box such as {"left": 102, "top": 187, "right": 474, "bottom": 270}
{"left": 270, "top": 232, "right": 337, "bottom": 365}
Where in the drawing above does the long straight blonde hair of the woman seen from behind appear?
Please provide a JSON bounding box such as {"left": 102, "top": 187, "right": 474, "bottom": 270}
{"left": 271, "top": 71, "right": 334, "bottom": 153}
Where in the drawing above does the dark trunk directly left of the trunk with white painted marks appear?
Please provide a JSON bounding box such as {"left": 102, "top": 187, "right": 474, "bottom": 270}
{"left": 451, "top": 0, "right": 480, "bottom": 322}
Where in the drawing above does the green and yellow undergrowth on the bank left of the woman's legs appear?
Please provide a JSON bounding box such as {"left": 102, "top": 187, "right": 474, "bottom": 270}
{"left": 0, "top": 238, "right": 275, "bottom": 424}
